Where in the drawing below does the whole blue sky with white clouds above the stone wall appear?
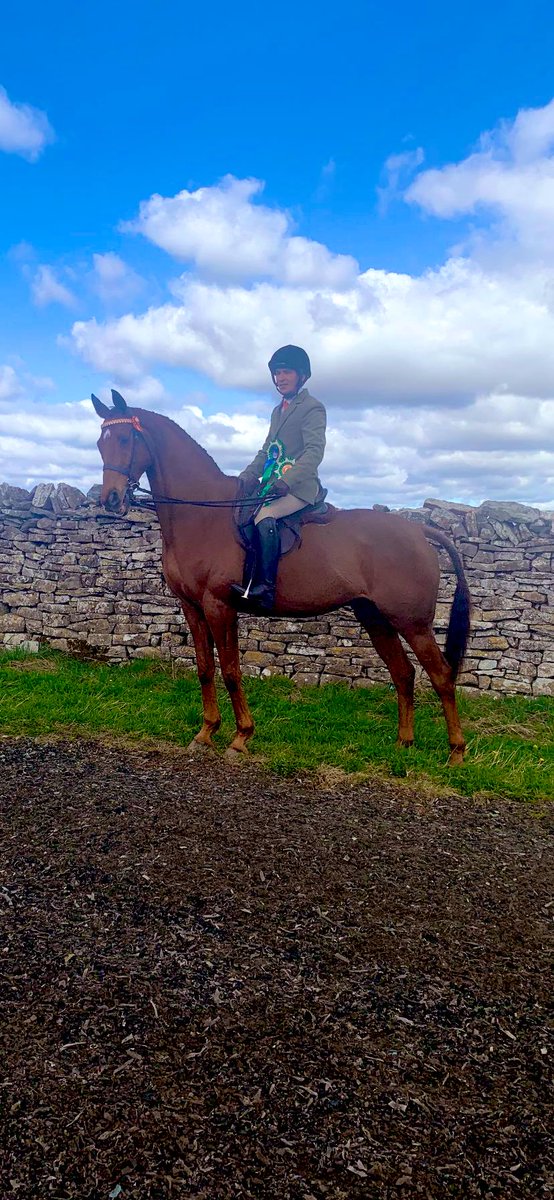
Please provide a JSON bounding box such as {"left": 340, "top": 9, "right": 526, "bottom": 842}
{"left": 0, "top": 0, "right": 554, "bottom": 505}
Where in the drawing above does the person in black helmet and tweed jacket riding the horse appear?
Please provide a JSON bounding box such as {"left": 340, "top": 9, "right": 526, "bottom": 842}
{"left": 227, "top": 346, "right": 326, "bottom": 612}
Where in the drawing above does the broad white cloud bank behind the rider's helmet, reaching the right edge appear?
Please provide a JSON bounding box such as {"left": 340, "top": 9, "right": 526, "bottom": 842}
{"left": 72, "top": 258, "right": 554, "bottom": 406}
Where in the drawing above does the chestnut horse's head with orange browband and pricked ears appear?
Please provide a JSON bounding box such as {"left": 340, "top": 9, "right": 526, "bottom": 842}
{"left": 91, "top": 389, "right": 152, "bottom": 516}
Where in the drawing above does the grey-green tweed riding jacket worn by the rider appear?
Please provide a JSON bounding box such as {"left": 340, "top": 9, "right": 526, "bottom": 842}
{"left": 241, "top": 388, "right": 326, "bottom": 504}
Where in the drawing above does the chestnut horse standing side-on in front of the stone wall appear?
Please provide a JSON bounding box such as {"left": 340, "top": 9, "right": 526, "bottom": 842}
{"left": 92, "top": 391, "right": 470, "bottom": 763}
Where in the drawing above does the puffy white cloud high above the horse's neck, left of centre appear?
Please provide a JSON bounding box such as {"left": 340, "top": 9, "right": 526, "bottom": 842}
{"left": 122, "top": 175, "right": 357, "bottom": 288}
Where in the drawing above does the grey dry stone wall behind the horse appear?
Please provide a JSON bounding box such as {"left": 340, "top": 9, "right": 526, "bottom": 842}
{"left": 0, "top": 484, "right": 554, "bottom": 696}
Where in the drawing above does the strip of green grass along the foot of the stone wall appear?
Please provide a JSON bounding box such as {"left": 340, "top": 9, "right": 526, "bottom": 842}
{"left": 0, "top": 648, "right": 554, "bottom": 802}
